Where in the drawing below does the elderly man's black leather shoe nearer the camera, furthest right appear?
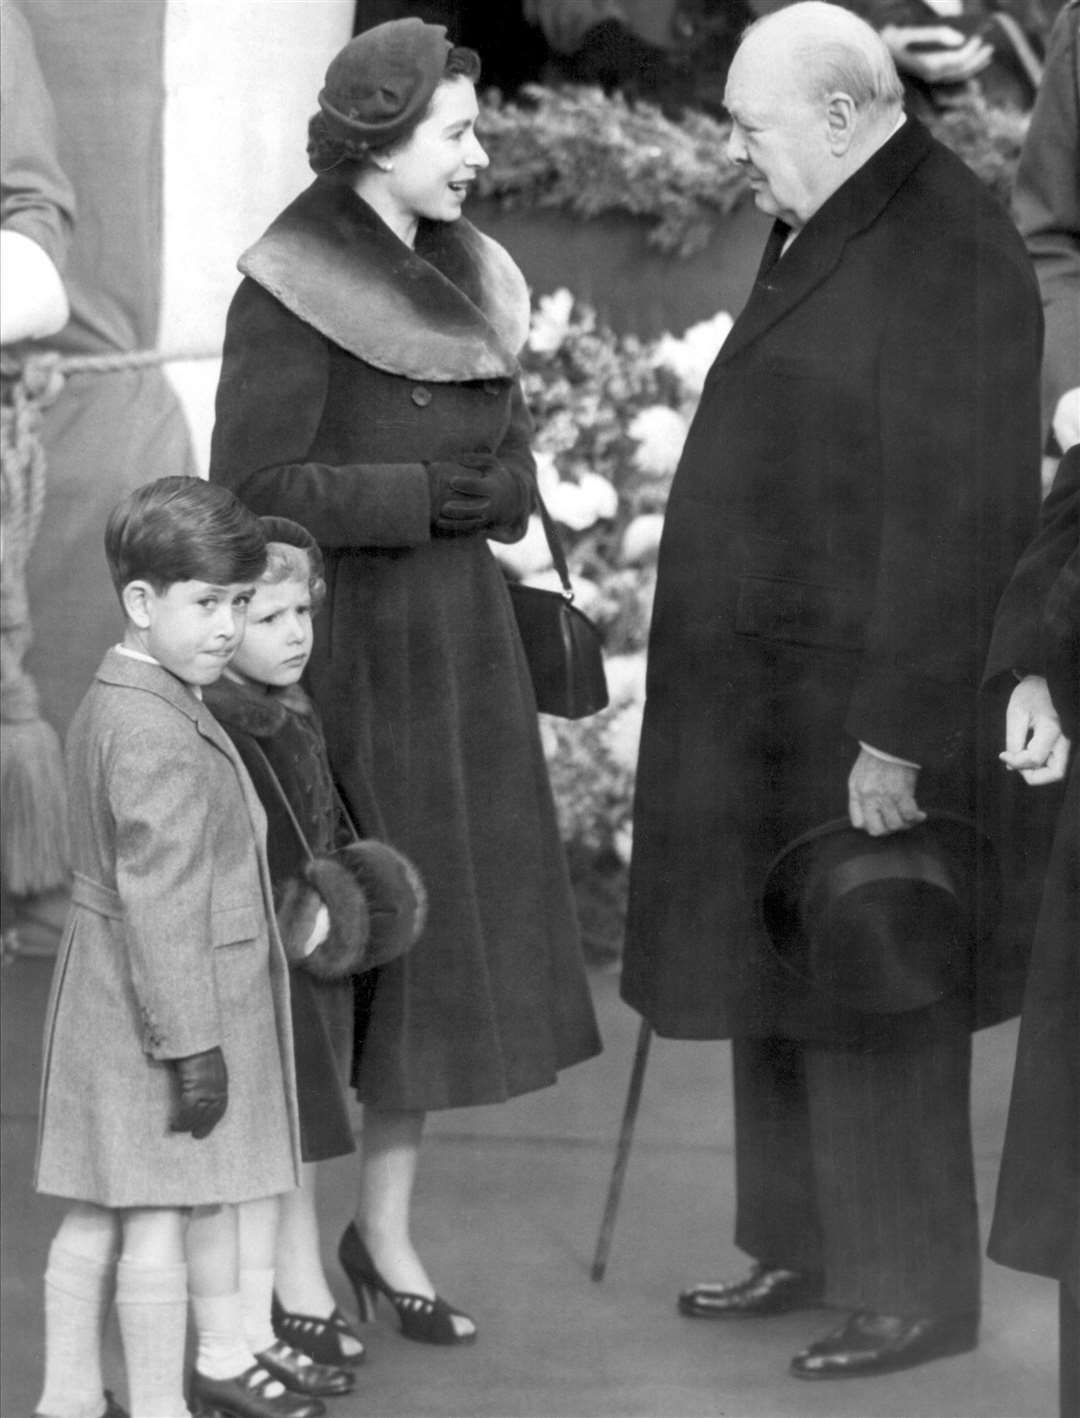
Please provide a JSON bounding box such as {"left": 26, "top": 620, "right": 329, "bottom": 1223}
{"left": 791, "top": 1310, "right": 979, "bottom": 1378}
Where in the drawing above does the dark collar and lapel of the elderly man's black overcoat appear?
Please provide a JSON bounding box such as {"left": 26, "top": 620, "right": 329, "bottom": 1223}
{"left": 713, "top": 118, "right": 933, "bottom": 369}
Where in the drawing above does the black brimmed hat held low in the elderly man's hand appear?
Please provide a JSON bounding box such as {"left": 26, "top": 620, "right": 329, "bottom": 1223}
{"left": 761, "top": 811, "right": 1001, "bottom": 1014}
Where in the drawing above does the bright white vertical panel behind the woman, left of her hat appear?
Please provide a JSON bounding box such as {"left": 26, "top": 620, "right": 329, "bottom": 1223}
{"left": 159, "top": 0, "right": 354, "bottom": 472}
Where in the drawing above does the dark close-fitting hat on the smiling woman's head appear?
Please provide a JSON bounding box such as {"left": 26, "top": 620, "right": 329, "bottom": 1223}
{"left": 319, "top": 17, "right": 452, "bottom": 149}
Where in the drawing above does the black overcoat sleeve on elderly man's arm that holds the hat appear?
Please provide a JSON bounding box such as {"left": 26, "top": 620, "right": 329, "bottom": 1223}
{"left": 846, "top": 214, "right": 1042, "bottom": 766}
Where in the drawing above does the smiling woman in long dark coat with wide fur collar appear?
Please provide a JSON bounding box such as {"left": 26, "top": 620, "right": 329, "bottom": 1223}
{"left": 210, "top": 20, "right": 600, "bottom": 1343}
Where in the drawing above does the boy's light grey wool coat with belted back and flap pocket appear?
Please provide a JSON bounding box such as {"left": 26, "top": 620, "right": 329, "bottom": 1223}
{"left": 35, "top": 649, "right": 299, "bottom": 1207}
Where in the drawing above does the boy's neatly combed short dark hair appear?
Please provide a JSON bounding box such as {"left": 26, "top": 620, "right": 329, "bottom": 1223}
{"left": 105, "top": 478, "right": 266, "bottom": 594}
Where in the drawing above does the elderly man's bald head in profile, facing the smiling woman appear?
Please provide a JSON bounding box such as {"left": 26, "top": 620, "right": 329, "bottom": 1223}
{"left": 724, "top": 0, "right": 903, "bottom": 230}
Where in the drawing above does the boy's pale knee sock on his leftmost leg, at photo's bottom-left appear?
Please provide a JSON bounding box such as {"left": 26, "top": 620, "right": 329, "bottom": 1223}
{"left": 35, "top": 1241, "right": 116, "bottom": 1418}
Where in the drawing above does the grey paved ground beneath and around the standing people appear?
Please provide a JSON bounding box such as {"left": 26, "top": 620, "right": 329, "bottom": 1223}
{"left": 0, "top": 918, "right": 1056, "bottom": 1418}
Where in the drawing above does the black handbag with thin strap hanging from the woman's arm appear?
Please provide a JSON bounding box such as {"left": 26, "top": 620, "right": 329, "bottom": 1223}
{"left": 509, "top": 492, "right": 608, "bottom": 719}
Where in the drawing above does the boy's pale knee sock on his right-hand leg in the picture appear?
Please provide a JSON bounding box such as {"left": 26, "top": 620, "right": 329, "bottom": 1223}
{"left": 116, "top": 1259, "right": 187, "bottom": 1418}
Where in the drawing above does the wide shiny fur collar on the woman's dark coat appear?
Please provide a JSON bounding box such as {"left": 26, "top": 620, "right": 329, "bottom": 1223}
{"left": 238, "top": 182, "right": 529, "bottom": 383}
